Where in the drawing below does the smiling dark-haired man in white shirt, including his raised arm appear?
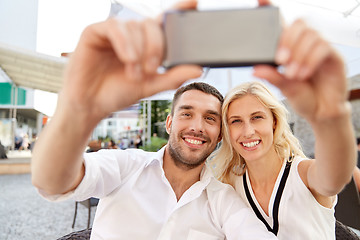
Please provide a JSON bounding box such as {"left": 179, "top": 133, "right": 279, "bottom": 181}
{"left": 32, "top": 2, "right": 275, "bottom": 239}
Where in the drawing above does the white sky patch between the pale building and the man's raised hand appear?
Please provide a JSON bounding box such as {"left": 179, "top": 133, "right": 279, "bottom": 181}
{"left": 36, "top": 0, "right": 110, "bottom": 57}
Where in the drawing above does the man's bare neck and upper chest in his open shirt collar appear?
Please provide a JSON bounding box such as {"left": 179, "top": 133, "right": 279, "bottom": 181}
{"left": 163, "top": 149, "right": 204, "bottom": 201}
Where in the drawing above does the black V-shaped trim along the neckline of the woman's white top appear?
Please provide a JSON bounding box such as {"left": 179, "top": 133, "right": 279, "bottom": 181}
{"left": 243, "top": 157, "right": 292, "bottom": 235}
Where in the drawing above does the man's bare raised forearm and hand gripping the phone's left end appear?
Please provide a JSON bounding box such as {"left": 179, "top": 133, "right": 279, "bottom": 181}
{"left": 32, "top": 6, "right": 201, "bottom": 194}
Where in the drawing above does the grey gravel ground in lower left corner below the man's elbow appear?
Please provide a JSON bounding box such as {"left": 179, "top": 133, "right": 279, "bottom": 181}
{"left": 0, "top": 174, "right": 96, "bottom": 240}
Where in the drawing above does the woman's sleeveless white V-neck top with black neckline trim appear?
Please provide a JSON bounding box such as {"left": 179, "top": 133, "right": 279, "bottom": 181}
{"left": 235, "top": 157, "right": 337, "bottom": 240}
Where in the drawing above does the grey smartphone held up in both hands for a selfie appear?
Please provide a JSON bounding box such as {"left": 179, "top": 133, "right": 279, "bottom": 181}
{"left": 163, "top": 6, "right": 281, "bottom": 68}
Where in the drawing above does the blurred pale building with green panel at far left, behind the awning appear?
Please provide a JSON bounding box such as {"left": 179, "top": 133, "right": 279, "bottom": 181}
{"left": 0, "top": 0, "right": 44, "bottom": 146}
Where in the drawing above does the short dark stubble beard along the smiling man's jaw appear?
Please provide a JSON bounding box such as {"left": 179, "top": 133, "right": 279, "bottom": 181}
{"left": 168, "top": 133, "right": 215, "bottom": 170}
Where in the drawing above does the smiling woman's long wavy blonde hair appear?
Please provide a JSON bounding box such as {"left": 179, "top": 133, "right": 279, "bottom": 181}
{"left": 209, "top": 82, "right": 305, "bottom": 186}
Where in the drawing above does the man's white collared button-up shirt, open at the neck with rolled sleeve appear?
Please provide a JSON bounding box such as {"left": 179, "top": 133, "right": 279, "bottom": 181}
{"left": 39, "top": 147, "right": 276, "bottom": 240}
